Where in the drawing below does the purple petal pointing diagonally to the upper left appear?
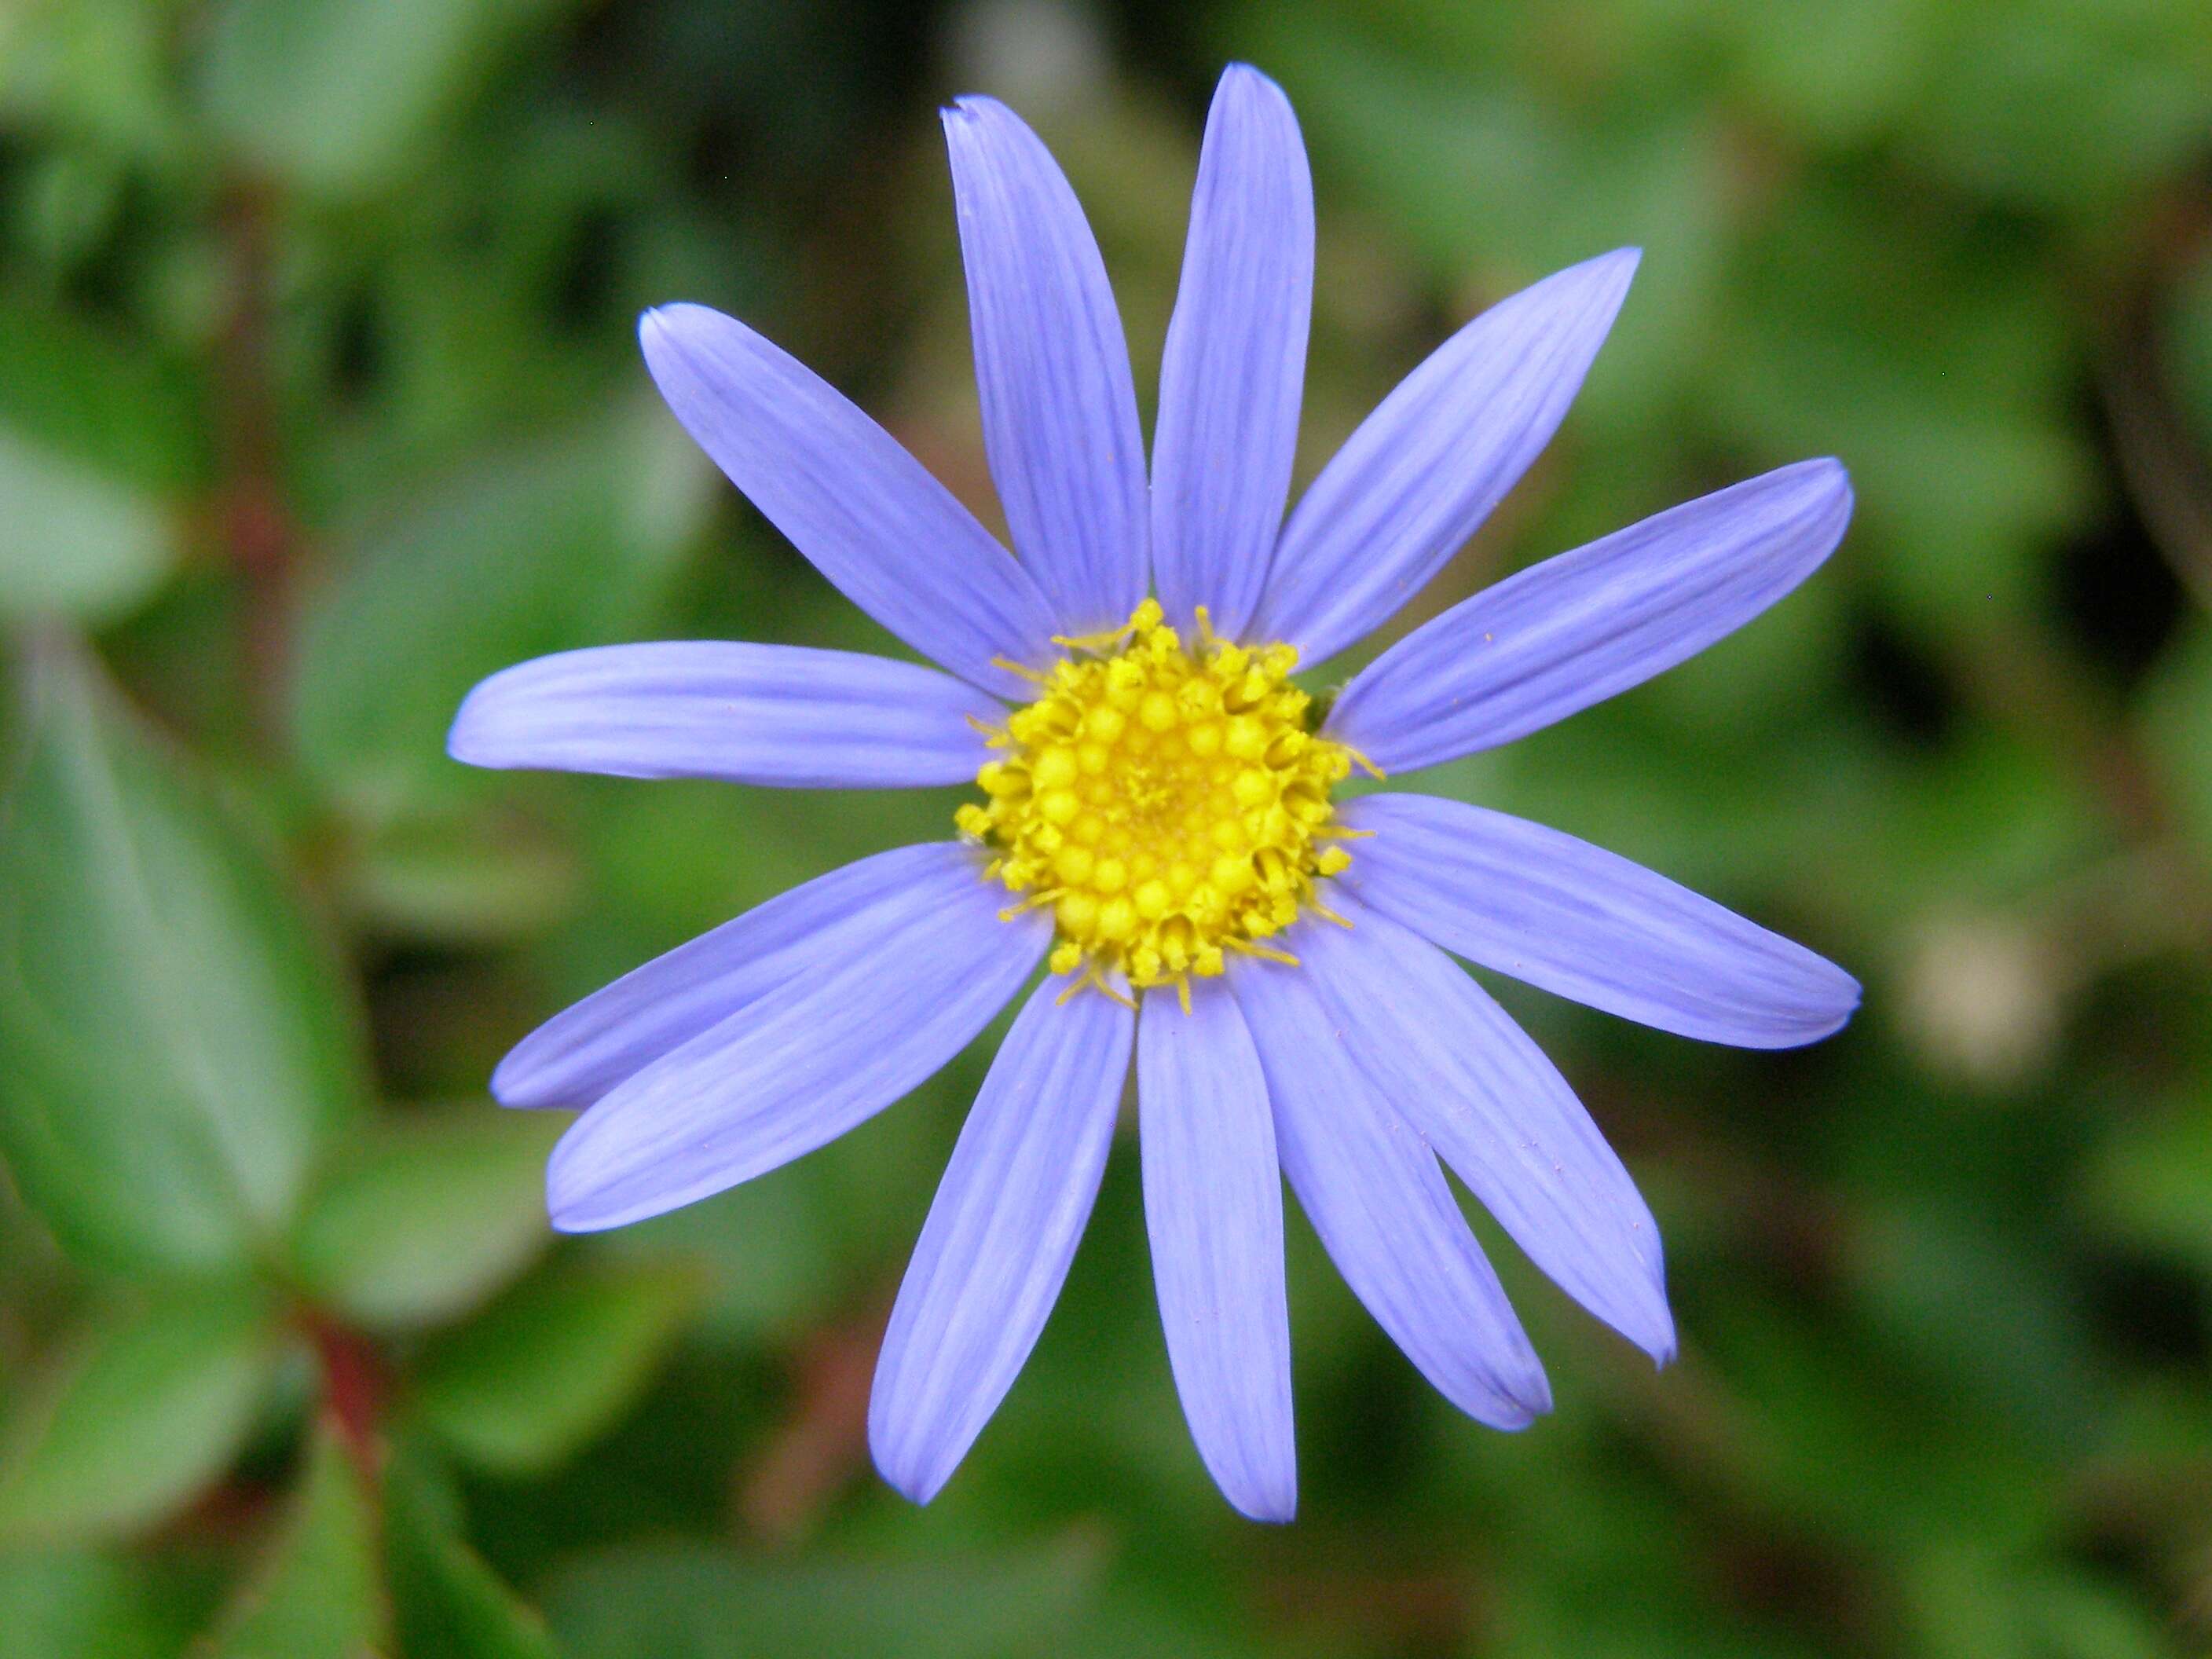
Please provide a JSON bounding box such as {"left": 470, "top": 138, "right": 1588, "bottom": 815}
{"left": 637, "top": 306, "right": 1053, "bottom": 701}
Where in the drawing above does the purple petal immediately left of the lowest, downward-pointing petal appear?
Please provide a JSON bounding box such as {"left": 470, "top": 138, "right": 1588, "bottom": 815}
{"left": 867, "top": 978, "right": 1137, "bottom": 1504}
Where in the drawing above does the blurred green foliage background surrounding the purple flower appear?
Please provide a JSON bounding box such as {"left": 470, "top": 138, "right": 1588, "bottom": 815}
{"left": 0, "top": 0, "right": 2212, "bottom": 1659}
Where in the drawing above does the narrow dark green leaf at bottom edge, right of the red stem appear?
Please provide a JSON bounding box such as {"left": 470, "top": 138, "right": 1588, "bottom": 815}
{"left": 385, "top": 1448, "right": 559, "bottom": 1659}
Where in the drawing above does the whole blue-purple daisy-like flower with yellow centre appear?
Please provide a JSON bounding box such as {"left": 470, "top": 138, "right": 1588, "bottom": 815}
{"left": 451, "top": 66, "right": 1858, "bottom": 1520}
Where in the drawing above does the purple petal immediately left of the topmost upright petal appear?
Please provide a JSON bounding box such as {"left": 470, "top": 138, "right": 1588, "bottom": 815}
{"left": 944, "top": 97, "right": 1146, "bottom": 635}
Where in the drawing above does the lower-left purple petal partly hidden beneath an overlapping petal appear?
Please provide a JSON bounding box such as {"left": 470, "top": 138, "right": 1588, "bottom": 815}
{"left": 491, "top": 840, "right": 982, "bottom": 1106}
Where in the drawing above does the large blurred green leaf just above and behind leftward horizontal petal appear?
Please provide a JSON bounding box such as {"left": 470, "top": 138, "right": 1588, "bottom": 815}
{"left": 292, "top": 407, "right": 710, "bottom": 827}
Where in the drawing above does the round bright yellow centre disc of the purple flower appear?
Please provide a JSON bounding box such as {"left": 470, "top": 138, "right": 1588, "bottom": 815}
{"left": 956, "top": 599, "right": 1358, "bottom": 1009}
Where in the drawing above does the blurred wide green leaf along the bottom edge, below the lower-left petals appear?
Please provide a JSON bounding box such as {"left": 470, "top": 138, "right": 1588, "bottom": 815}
{"left": 551, "top": 1542, "right": 1101, "bottom": 1659}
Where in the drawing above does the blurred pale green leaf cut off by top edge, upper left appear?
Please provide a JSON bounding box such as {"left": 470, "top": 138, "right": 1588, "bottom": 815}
{"left": 201, "top": 0, "right": 579, "bottom": 195}
